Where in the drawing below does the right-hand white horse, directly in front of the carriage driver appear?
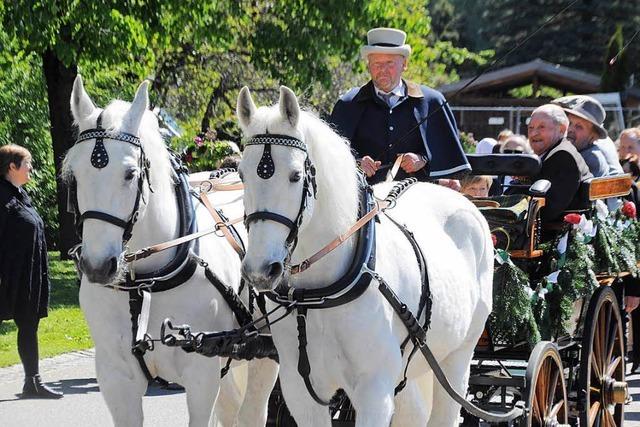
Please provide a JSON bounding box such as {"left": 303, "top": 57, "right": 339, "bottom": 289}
{"left": 237, "top": 87, "right": 493, "bottom": 427}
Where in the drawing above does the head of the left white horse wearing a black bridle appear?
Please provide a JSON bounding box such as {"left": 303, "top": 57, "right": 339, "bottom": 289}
{"left": 63, "top": 76, "right": 150, "bottom": 284}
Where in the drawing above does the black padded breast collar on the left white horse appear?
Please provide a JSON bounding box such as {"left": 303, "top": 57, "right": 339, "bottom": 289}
{"left": 121, "top": 156, "right": 199, "bottom": 292}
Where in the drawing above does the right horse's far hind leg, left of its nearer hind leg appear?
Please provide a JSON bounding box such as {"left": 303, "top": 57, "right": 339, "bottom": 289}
{"left": 391, "top": 375, "right": 431, "bottom": 427}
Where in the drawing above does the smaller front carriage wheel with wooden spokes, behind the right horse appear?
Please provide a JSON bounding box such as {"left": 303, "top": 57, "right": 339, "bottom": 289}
{"left": 525, "top": 341, "right": 568, "bottom": 427}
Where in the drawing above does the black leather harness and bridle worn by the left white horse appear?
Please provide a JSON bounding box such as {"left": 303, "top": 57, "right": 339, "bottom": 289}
{"left": 68, "top": 113, "right": 253, "bottom": 381}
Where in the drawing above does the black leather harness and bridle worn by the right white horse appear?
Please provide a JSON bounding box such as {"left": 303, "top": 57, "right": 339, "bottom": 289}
{"left": 240, "top": 134, "right": 431, "bottom": 406}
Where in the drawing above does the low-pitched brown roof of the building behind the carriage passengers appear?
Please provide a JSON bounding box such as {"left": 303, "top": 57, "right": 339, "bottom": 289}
{"left": 438, "top": 58, "right": 640, "bottom": 97}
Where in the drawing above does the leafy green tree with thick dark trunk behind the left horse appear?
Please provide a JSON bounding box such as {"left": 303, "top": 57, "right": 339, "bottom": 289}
{"left": 0, "top": 0, "right": 237, "bottom": 256}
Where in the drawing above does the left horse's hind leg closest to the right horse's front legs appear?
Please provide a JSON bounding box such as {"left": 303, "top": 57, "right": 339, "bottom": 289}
{"left": 238, "top": 359, "right": 278, "bottom": 427}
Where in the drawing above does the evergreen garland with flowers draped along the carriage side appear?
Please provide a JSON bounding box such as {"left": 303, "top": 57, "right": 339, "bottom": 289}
{"left": 489, "top": 211, "right": 640, "bottom": 348}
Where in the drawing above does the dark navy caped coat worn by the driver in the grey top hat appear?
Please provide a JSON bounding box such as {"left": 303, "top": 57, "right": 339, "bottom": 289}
{"left": 329, "top": 80, "right": 471, "bottom": 182}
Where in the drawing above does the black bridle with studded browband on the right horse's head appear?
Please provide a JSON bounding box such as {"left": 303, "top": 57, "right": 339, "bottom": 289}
{"left": 244, "top": 134, "right": 318, "bottom": 262}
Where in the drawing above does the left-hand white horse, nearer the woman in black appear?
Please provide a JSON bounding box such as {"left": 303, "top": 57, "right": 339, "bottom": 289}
{"left": 63, "top": 76, "right": 277, "bottom": 426}
